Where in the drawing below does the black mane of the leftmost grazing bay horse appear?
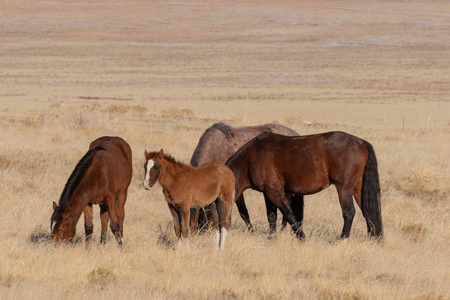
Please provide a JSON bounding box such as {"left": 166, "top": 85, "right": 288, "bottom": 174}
{"left": 52, "top": 146, "right": 105, "bottom": 220}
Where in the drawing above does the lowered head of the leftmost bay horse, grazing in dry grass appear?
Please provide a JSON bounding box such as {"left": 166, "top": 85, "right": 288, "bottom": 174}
{"left": 50, "top": 202, "right": 75, "bottom": 242}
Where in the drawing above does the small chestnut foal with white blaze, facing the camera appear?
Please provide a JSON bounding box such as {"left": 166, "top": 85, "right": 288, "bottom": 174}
{"left": 143, "top": 149, "right": 235, "bottom": 250}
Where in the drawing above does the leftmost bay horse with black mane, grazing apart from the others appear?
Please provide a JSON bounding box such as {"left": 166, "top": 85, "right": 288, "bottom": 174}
{"left": 51, "top": 137, "right": 132, "bottom": 245}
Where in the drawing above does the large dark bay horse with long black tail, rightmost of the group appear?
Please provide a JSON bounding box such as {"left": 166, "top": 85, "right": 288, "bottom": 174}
{"left": 226, "top": 131, "right": 383, "bottom": 239}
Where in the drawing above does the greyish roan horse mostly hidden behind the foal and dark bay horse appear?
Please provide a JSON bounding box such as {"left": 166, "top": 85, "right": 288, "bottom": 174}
{"left": 190, "top": 122, "right": 303, "bottom": 233}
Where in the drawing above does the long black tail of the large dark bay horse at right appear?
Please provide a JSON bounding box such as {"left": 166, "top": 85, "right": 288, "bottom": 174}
{"left": 361, "top": 141, "right": 383, "bottom": 237}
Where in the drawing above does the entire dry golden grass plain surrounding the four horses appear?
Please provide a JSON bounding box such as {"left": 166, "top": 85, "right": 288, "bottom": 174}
{"left": 0, "top": 0, "right": 450, "bottom": 299}
